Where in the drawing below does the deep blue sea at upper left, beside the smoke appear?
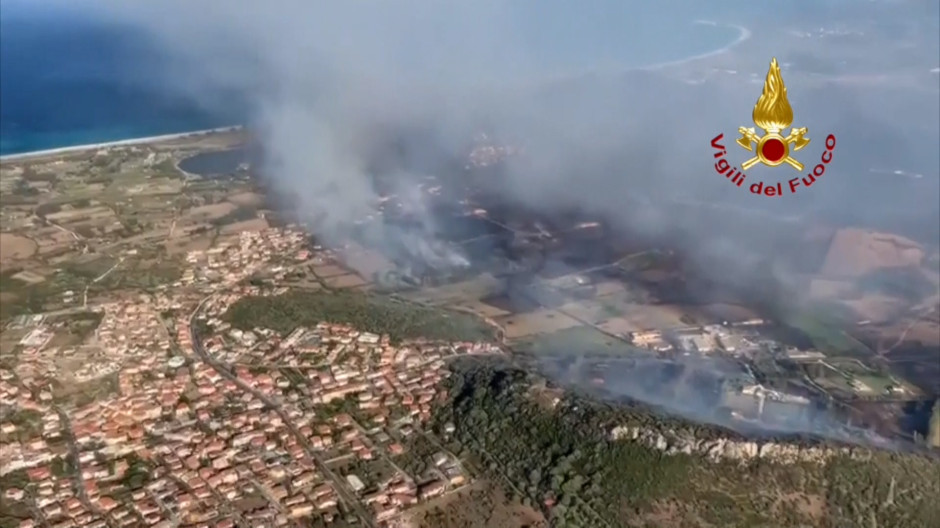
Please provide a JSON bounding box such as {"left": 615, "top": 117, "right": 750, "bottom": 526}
{"left": 0, "top": 9, "right": 241, "bottom": 154}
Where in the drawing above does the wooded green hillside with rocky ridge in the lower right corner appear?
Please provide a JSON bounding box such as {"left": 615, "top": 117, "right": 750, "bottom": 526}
{"left": 435, "top": 365, "right": 940, "bottom": 528}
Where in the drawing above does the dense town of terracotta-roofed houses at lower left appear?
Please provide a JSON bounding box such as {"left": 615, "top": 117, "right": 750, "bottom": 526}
{"left": 0, "top": 229, "right": 500, "bottom": 527}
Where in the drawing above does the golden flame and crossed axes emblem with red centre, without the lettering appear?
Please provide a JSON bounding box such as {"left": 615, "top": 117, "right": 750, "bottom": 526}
{"left": 738, "top": 58, "right": 810, "bottom": 171}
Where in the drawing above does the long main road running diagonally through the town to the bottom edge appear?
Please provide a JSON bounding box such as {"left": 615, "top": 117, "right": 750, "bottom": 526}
{"left": 189, "top": 302, "right": 376, "bottom": 528}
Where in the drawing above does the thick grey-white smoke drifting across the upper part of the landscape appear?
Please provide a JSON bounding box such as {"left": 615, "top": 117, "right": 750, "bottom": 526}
{"left": 58, "top": 0, "right": 940, "bottom": 442}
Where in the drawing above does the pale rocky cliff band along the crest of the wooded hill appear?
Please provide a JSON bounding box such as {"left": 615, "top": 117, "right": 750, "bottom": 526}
{"left": 610, "top": 425, "right": 871, "bottom": 464}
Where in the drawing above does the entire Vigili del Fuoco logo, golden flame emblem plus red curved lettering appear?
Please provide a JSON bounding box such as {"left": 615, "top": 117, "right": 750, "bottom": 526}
{"left": 711, "top": 58, "right": 836, "bottom": 197}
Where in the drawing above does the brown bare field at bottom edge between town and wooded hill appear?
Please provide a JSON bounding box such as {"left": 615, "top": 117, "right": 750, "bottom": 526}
{"left": 408, "top": 482, "right": 548, "bottom": 528}
